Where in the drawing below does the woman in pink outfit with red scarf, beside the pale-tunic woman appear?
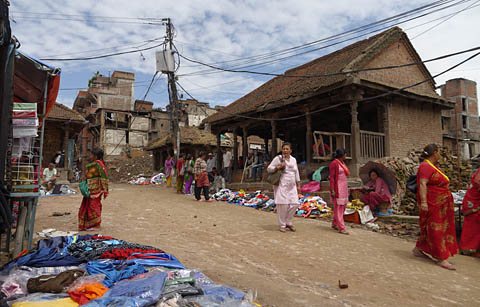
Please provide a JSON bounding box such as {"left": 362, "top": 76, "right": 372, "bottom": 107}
{"left": 330, "top": 148, "right": 350, "bottom": 235}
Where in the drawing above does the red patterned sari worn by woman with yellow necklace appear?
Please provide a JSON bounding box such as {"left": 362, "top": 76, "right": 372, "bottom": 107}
{"left": 417, "top": 162, "right": 458, "bottom": 260}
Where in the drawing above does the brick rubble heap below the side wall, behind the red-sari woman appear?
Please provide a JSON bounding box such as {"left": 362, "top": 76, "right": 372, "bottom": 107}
{"left": 375, "top": 149, "right": 473, "bottom": 215}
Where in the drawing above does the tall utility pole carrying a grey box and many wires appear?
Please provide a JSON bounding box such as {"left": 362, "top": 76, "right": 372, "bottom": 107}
{"left": 167, "top": 18, "right": 180, "bottom": 160}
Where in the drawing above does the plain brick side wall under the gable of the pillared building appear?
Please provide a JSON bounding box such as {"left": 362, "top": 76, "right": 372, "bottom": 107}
{"left": 388, "top": 101, "right": 443, "bottom": 157}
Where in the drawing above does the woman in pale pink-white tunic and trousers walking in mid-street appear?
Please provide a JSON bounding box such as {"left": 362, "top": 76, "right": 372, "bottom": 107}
{"left": 267, "top": 143, "right": 300, "bottom": 232}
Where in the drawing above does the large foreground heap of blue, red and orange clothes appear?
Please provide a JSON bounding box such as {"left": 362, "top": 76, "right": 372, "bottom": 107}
{"left": 0, "top": 235, "right": 259, "bottom": 307}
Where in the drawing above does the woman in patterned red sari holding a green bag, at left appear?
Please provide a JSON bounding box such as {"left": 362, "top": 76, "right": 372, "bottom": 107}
{"left": 78, "top": 148, "right": 108, "bottom": 230}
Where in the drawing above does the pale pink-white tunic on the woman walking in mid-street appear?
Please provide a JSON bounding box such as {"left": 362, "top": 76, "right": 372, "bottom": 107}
{"left": 267, "top": 156, "right": 300, "bottom": 205}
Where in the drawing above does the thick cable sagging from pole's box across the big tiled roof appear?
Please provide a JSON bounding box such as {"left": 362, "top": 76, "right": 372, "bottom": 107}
{"left": 179, "top": 46, "right": 480, "bottom": 78}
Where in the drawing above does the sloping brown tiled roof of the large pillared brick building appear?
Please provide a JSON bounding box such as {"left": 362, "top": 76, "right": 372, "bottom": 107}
{"left": 204, "top": 27, "right": 438, "bottom": 122}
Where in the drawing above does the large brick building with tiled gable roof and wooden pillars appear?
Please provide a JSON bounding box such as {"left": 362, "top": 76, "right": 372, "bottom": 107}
{"left": 205, "top": 27, "right": 453, "bottom": 180}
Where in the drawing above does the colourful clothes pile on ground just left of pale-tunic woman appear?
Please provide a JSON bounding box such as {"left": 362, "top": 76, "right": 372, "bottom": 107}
{"left": 212, "top": 189, "right": 275, "bottom": 210}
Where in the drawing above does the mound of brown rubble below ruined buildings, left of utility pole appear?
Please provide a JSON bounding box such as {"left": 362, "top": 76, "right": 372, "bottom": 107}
{"left": 106, "top": 153, "right": 154, "bottom": 183}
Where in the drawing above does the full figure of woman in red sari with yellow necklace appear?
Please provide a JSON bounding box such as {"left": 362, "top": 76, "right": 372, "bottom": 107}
{"left": 413, "top": 144, "right": 458, "bottom": 270}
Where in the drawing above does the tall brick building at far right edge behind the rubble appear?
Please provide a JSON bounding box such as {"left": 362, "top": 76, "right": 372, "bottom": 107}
{"left": 441, "top": 78, "right": 480, "bottom": 159}
